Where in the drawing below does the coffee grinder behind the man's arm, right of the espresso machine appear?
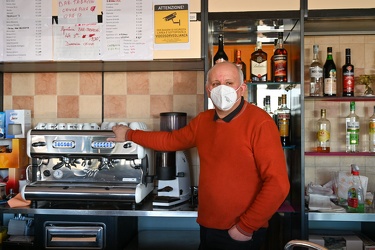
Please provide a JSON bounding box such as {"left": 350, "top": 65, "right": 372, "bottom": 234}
{"left": 153, "top": 112, "right": 190, "bottom": 207}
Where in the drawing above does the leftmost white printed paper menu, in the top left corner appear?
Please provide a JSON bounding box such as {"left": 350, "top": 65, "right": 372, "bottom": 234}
{"left": 0, "top": 0, "right": 52, "bottom": 62}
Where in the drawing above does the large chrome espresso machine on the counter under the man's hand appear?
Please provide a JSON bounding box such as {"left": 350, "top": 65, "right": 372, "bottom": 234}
{"left": 21, "top": 122, "right": 154, "bottom": 205}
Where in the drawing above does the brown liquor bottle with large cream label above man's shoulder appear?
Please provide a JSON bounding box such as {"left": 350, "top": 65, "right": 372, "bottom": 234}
{"left": 250, "top": 41, "right": 267, "bottom": 82}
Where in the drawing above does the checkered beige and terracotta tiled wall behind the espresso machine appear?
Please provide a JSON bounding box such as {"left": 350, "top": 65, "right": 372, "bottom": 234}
{"left": 4, "top": 71, "right": 204, "bottom": 185}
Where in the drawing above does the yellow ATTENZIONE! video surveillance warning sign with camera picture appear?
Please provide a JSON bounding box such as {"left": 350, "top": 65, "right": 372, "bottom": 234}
{"left": 154, "top": 4, "right": 189, "bottom": 44}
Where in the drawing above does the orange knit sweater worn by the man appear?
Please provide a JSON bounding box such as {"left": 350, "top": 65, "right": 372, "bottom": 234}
{"left": 127, "top": 102, "right": 289, "bottom": 234}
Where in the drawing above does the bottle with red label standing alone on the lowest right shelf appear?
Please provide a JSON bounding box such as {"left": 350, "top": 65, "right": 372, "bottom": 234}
{"left": 347, "top": 164, "right": 365, "bottom": 213}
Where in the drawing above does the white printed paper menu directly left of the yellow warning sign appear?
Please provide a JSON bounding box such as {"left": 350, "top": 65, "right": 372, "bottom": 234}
{"left": 101, "top": 0, "right": 153, "bottom": 61}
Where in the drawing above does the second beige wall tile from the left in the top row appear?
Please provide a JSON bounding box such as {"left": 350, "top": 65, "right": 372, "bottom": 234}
{"left": 57, "top": 73, "right": 80, "bottom": 95}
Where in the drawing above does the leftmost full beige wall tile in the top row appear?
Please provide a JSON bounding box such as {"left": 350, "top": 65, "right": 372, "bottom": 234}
{"left": 12, "top": 73, "right": 35, "bottom": 96}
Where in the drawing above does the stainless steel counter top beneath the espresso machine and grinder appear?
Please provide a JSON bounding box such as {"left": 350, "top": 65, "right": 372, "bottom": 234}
{"left": 0, "top": 197, "right": 197, "bottom": 218}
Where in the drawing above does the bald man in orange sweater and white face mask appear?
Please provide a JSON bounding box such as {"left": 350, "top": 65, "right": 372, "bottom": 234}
{"left": 108, "top": 62, "right": 289, "bottom": 250}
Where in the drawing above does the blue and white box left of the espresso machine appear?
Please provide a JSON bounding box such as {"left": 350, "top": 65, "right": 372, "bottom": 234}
{"left": 5, "top": 109, "right": 31, "bottom": 139}
